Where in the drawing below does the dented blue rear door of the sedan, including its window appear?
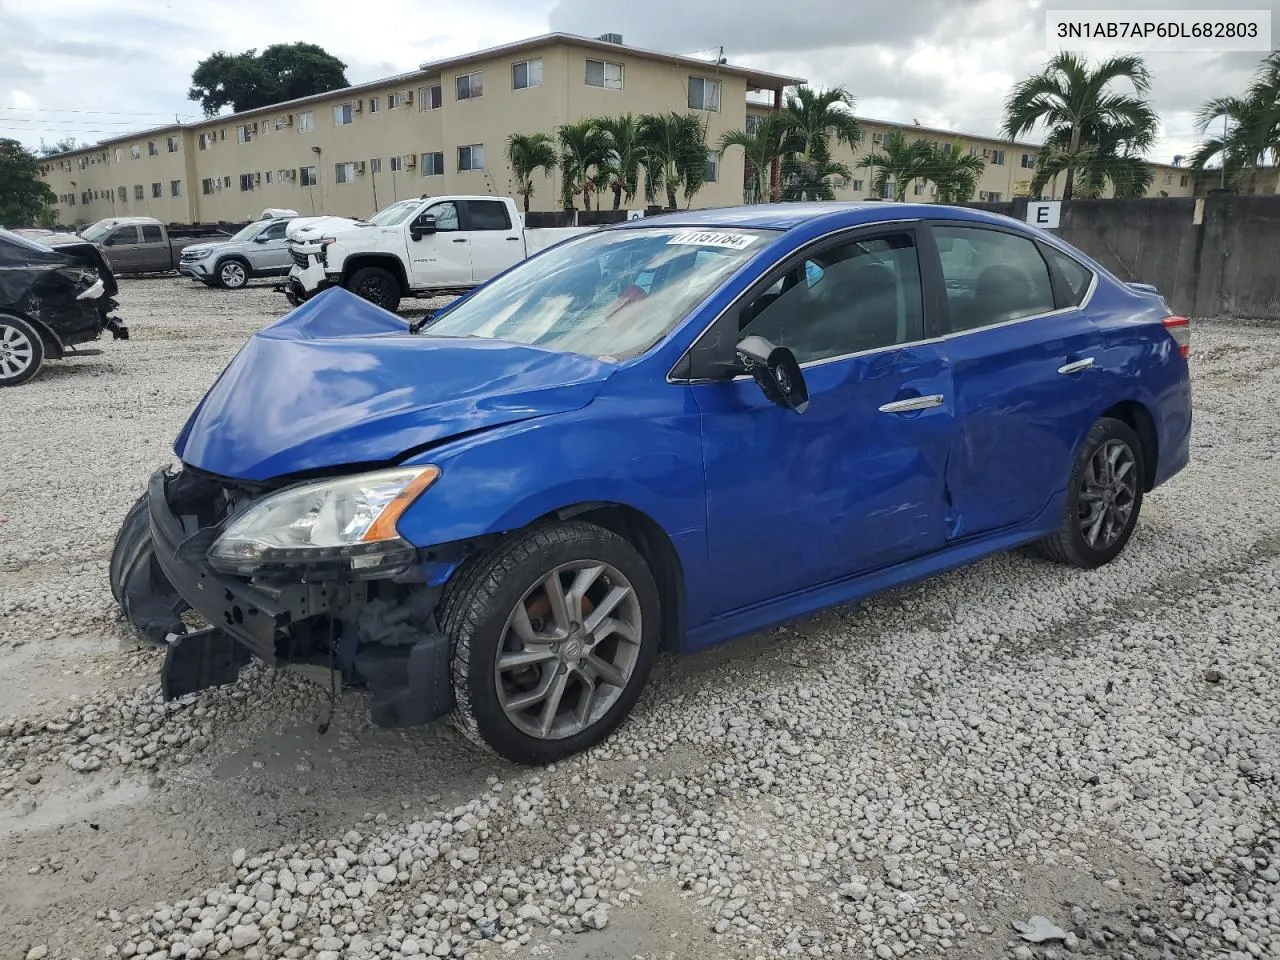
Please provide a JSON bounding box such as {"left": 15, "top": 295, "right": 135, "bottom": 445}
{"left": 933, "top": 223, "right": 1101, "bottom": 539}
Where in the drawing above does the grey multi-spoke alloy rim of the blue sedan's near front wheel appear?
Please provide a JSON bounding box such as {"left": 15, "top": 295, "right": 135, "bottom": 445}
{"left": 494, "top": 561, "right": 643, "bottom": 740}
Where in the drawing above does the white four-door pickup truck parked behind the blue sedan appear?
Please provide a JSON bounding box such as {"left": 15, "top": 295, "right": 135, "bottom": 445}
{"left": 279, "top": 197, "right": 596, "bottom": 311}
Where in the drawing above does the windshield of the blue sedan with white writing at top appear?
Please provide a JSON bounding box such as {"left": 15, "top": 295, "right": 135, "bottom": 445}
{"left": 424, "top": 228, "right": 772, "bottom": 360}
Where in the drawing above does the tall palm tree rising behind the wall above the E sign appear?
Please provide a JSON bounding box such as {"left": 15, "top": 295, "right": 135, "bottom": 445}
{"left": 1004, "top": 51, "right": 1158, "bottom": 200}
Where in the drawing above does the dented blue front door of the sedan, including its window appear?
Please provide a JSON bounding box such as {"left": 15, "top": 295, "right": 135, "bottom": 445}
{"left": 692, "top": 227, "right": 956, "bottom": 614}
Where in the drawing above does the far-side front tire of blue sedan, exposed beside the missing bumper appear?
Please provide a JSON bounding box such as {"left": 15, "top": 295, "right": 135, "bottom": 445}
{"left": 108, "top": 494, "right": 189, "bottom": 646}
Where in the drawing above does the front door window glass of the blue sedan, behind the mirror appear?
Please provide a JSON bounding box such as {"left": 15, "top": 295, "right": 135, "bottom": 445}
{"left": 740, "top": 233, "right": 923, "bottom": 364}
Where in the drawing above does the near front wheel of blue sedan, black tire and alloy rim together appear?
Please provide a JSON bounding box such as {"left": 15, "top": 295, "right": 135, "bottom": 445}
{"left": 440, "top": 521, "right": 659, "bottom": 764}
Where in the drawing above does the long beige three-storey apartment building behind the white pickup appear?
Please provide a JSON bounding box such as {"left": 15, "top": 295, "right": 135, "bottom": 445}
{"left": 45, "top": 33, "right": 804, "bottom": 224}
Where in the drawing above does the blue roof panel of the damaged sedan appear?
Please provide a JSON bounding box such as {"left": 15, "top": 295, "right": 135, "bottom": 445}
{"left": 618, "top": 200, "right": 1025, "bottom": 230}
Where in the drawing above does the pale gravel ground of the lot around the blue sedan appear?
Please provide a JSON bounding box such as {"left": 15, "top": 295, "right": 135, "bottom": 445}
{"left": 0, "top": 279, "right": 1280, "bottom": 960}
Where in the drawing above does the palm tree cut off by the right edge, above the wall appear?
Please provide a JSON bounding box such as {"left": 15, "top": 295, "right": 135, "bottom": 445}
{"left": 1190, "top": 51, "right": 1280, "bottom": 189}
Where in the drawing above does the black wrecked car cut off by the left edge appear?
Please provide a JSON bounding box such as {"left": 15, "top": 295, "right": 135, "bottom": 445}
{"left": 0, "top": 229, "right": 129, "bottom": 387}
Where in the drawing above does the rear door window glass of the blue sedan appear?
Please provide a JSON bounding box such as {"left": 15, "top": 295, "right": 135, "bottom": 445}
{"left": 934, "top": 227, "right": 1055, "bottom": 332}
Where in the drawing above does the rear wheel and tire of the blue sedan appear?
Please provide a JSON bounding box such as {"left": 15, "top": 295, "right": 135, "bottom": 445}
{"left": 1036, "top": 417, "right": 1146, "bottom": 570}
